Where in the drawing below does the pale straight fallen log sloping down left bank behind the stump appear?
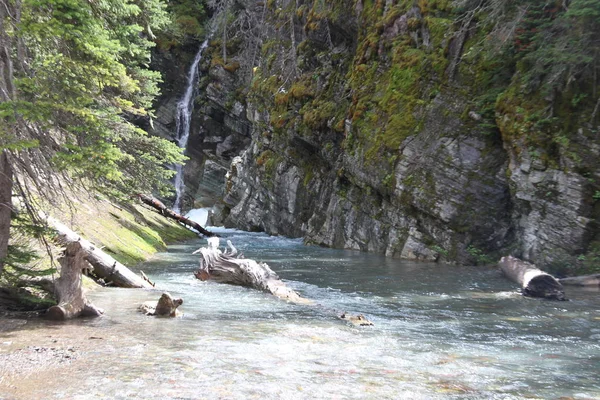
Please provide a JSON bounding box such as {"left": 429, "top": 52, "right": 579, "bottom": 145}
{"left": 48, "top": 218, "right": 153, "bottom": 289}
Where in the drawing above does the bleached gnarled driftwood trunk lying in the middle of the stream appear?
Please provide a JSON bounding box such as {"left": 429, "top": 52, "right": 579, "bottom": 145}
{"left": 194, "top": 237, "right": 312, "bottom": 304}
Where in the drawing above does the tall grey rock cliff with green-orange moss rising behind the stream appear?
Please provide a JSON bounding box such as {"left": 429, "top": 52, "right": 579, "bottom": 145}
{"left": 196, "top": 0, "right": 600, "bottom": 270}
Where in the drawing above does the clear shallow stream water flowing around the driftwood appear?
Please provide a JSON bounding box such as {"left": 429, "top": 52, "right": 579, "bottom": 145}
{"left": 0, "top": 230, "right": 600, "bottom": 399}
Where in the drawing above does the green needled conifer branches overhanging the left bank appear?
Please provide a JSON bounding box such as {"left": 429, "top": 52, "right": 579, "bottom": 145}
{"left": 0, "top": 0, "right": 188, "bottom": 272}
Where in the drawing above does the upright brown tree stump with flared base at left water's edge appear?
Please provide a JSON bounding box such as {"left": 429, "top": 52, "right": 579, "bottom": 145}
{"left": 46, "top": 242, "right": 103, "bottom": 320}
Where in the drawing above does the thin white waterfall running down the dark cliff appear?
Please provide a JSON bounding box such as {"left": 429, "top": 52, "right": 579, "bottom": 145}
{"left": 173, "top": 39, "right": 209, "bottom": 213}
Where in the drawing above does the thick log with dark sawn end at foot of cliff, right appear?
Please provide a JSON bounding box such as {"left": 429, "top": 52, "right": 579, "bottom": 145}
{"left": 498, "top": 256, "right": 566, "bottom": 300}
